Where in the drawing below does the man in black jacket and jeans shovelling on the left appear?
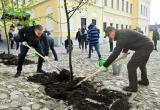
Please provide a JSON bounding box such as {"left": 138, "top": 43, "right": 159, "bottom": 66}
{"left": 15, "top": 25, "right": 49, "bottom": 77}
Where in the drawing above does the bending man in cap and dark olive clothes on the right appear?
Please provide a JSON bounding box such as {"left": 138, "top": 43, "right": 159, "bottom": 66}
{"left": 99, "top": 27, "right": 154, "bottom": 92}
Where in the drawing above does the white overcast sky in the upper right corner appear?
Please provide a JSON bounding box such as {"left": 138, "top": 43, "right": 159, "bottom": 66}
{"left": 150, "top": 0, "right": 160, "bottom": 24}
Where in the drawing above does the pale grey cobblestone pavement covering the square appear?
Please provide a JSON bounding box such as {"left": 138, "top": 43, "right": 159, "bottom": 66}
{"left": 0, "top": 40, "right": 160, "bottom": 110}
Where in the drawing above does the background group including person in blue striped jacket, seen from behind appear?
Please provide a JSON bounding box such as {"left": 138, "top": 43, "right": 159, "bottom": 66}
{"left": 76, "top": 23, "right": 102, "bottom": 60}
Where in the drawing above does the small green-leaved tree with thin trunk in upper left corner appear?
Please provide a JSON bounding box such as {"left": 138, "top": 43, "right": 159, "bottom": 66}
{"left": 0, "top": 0, "right": 30, "bottom": 55}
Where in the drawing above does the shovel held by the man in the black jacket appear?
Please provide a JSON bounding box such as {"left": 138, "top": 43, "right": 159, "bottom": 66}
{"left": 23, "top": 44, "right": 63, "bottom": 71}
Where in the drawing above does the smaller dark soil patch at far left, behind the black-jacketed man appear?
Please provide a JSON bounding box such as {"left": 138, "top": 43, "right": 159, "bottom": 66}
{"left": 0, "top": 53, "right": 35, "bottom": 65}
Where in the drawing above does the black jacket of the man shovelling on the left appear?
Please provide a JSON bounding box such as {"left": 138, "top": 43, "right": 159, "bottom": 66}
{"left": 19, "top": 26, "right": 49, "bottom": 55}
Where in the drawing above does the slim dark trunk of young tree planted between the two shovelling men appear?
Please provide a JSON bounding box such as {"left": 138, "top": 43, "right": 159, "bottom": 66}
{"left": 64, "top": 0, "right": 73, "bottom": 81}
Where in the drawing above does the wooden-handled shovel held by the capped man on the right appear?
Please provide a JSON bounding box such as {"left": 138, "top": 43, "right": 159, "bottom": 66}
{"left": 74, "top": 53, "right": 130, "bottom": 87}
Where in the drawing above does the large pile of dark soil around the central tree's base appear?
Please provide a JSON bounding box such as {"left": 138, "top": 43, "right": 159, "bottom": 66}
{"left": 28, "top": 71, "right": 131, "bottom": 110}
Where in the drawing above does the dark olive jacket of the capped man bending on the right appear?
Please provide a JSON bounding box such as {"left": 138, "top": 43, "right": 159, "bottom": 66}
{"left": 104, "top": 30, "right": 153, "bottom": 67}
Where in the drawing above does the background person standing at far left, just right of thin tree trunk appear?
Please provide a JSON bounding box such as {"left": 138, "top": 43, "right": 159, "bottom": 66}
{"left": 8, "top": 25, "right": 15, "bottom": 49}
